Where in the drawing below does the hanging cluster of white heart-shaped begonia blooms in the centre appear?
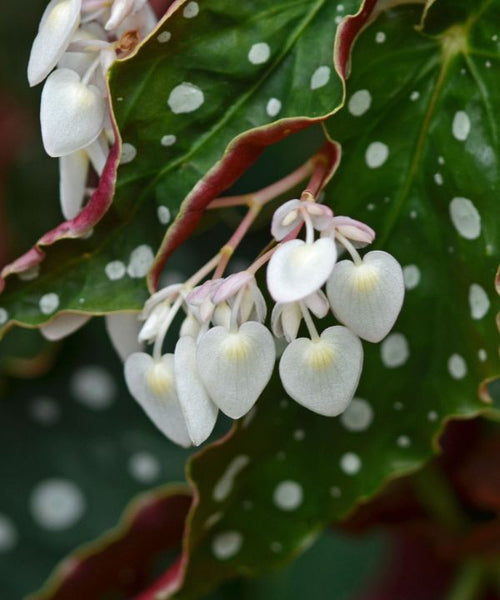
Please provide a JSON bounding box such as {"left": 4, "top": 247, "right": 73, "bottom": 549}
{"left": 125, "top": 192, "right": 404, "bottom": 446}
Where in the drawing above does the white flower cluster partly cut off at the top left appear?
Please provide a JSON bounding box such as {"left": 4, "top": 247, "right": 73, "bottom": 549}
{"left": 28, "top": 0, "right": 156, "bottom": 219}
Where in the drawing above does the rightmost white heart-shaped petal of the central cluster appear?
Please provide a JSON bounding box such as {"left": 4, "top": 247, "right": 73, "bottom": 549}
{"left": 326, "top": 250, "right": 405, "bottom": 342}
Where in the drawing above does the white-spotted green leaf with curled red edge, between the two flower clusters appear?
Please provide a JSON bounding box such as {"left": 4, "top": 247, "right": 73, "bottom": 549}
{"left": 0, "top": 0, "right": 368, "bottom": 326}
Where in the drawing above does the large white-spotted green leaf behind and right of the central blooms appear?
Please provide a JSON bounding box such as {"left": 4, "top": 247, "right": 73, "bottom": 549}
{"left": 136, "top": 0, "right": 500, "bottom": 599}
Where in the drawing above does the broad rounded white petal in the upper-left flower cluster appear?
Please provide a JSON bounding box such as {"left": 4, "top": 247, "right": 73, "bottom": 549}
{"left": 40, "top": 69, "right": 106, "bottom": 156}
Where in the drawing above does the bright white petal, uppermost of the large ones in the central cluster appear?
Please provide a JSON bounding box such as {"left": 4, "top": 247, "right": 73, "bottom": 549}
{"left": 267, "top": 238, "right": 337, "bottom": 302}
